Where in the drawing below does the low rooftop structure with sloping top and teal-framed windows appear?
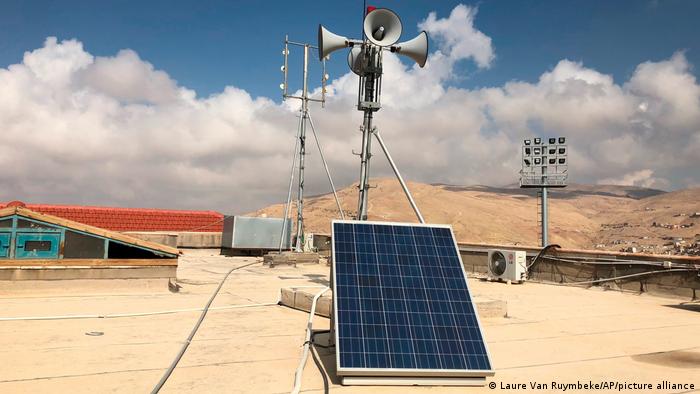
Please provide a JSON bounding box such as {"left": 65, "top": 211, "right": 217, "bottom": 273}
{"left": 0, "top": 203, "right": 179, "bottom": 280}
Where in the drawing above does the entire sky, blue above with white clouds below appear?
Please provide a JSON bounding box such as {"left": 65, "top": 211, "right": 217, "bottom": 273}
{"left": 0, "top": 0, "right": 700, "bottom": 209}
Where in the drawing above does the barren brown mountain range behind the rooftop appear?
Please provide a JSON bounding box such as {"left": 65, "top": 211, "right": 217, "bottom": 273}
{"left": 251, "top": 179, "right": 700, "bottom": 253}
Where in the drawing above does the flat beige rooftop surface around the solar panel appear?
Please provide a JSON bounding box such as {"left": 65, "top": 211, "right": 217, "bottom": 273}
{"left": 0, "top": 250, "right": 700, "bottom": 393}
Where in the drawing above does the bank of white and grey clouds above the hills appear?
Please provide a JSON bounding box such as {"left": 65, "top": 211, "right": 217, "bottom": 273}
{"left": 0, "top": 6, "right": 700, "bottom": 213}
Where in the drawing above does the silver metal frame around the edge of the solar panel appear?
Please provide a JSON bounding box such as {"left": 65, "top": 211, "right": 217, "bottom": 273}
{"left": 331, "top": 220, "right": 495, "bottom": 383}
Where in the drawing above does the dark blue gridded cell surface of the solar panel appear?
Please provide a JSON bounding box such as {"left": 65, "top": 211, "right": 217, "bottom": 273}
{"left": 333, "top": 222, "right": 491, "bottom": 371}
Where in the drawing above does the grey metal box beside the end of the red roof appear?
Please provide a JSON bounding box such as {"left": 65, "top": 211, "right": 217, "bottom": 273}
{"left": 221, "top": 216, "right": 292, "bottom": 249}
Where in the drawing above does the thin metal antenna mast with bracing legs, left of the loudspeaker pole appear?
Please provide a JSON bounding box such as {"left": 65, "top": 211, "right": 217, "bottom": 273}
{"left": 279, "top": 36, "right": 345, "bottom": 252}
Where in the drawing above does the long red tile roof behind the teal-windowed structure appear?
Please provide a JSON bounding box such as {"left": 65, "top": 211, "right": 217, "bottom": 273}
{"left": 0, "top": 201, "right": 224, "bottom": 232}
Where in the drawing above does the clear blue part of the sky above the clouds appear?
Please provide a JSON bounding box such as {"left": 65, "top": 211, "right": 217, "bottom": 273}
{"left": 0, "top": 0, "right": 700, "bottom": 100}
